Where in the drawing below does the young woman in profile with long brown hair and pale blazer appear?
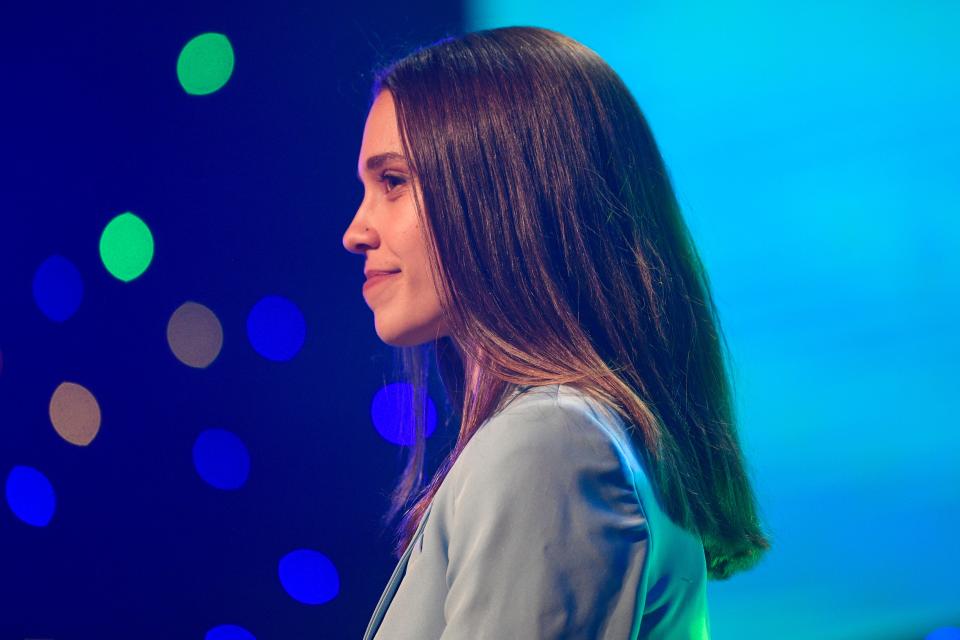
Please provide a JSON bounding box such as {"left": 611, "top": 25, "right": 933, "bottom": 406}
{"left": 343, "top": 22, "right": 769, "bottom": 640}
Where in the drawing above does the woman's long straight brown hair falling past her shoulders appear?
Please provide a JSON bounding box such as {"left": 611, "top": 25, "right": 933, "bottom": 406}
{"left": 371, "top": 27, "right": 770, "bottom": 579}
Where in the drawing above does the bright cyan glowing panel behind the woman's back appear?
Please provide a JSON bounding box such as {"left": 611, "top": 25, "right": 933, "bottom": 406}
{"left": 467, "top": 0, "right": 960, "bottom": 640}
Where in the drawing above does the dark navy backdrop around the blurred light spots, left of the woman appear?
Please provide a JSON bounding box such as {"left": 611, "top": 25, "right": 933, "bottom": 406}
{"left": 0, "top": 0, "right": 461, "bottom": 639}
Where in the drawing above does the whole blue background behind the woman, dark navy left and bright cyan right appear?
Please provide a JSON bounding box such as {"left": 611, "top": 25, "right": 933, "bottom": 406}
{"left": 0, "top": 0, "right": 960, "bottom": 640}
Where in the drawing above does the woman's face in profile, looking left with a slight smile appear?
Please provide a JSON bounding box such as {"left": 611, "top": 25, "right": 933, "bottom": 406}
{"left": 343, "top": 91, "right": 447, "bottom": 347}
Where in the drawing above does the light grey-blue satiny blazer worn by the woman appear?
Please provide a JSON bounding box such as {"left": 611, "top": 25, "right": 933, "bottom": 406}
{"left": 364, "top": 385, "right": 709, "bottom": 640}
